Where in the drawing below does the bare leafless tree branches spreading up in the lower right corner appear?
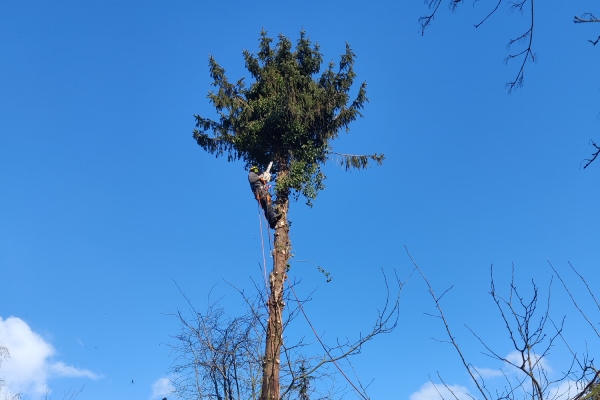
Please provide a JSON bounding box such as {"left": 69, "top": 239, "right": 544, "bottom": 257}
{"left": 409, "top": 245, "right": 600, "bottom": 400}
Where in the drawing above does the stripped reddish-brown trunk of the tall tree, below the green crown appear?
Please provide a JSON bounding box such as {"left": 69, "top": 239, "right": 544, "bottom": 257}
{"left": 260, "top": 182, "right": 290, "bottom": 400}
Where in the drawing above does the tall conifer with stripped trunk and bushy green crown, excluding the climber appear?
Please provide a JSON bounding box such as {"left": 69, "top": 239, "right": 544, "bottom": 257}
{"left": 194, "top": 30, "right": 384, "bottom": 400}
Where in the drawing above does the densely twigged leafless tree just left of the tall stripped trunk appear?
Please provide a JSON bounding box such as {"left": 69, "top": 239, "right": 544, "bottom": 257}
{"left": 171, "top": 284, "right": 263, "bottom": 400}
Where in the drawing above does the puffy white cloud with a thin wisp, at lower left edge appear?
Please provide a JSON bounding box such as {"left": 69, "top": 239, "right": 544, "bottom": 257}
{"left": 0, "top": 317, "right": 100, "bottom": 397}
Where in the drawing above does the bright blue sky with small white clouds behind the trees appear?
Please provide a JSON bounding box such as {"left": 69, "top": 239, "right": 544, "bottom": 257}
{"left": 0, "top": 0, "right": 600, "bottom": 400}
